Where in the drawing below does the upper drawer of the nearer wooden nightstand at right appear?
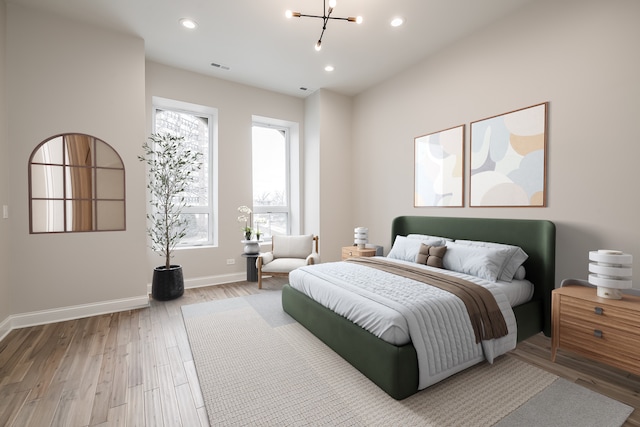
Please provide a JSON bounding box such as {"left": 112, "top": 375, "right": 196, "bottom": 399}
{"left": 560, "top": 297, "right": 640, "bottom": 328}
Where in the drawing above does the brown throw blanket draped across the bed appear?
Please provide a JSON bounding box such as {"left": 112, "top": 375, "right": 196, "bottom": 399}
{"left": 346, "top": 257, "right": 509, "bottom": 344}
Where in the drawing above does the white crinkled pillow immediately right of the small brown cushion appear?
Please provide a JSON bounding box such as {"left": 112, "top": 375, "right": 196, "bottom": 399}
{"left": 442, "top": 242, "right": 510, "bottom": 282}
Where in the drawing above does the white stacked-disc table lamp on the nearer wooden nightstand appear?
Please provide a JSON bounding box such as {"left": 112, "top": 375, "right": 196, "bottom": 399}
{"left": 589, "top": 249, "right": 633, "bottom": 299}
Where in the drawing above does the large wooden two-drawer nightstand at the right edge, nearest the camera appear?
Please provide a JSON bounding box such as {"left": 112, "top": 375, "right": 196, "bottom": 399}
{"left": 551, "top": 286, "right": 640, "bottom": 375}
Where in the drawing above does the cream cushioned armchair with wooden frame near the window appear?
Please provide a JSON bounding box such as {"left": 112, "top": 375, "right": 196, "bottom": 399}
{"left": 256, "top": 234, "right": 320, "bottom": 289}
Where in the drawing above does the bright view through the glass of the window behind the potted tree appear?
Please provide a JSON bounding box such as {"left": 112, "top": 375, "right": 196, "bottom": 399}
{"left": 155, "top": 108, "right": 213, "bottom": 246}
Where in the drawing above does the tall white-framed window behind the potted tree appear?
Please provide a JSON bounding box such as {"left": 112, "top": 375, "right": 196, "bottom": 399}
{"left": 153, "top": 97, "right": 217, "bottom": 247}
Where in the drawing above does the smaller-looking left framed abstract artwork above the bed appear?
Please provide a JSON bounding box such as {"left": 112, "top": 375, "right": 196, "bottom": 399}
{"left": 413, "top": 124, "right": 465, "bottom": 207}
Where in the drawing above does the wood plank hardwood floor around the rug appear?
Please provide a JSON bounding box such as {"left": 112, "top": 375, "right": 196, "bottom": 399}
{"left": 0, "top": 278, "right": 640, "bottom": 427}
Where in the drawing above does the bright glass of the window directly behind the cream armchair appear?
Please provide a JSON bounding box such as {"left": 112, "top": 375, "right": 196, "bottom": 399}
{"left": 252, "top": 122, "right": 291, "bottom": 240}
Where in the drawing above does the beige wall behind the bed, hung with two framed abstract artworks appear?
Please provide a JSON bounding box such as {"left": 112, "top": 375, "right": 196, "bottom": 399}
{"left": 352, "top": 0, "right": 640, "bottom": 288}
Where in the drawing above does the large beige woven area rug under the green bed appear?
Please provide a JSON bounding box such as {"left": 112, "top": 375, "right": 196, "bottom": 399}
{"left": 182, "top": 291, "right": 632, "bottom": 427}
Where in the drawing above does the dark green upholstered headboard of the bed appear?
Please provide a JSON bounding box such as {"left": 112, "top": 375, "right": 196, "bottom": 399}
{"left": 391, "top": 216, "right": 556, "bottom": 336}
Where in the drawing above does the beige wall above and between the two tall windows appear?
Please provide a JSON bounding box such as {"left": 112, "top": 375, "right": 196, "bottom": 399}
{"left": 146, "top": 62, "right": 304, "bottom": 286}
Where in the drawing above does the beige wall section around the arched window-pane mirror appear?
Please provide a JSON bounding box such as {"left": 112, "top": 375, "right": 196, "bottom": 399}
{"left": 3, "top": 3, "right": 147, "bottom": 314}
